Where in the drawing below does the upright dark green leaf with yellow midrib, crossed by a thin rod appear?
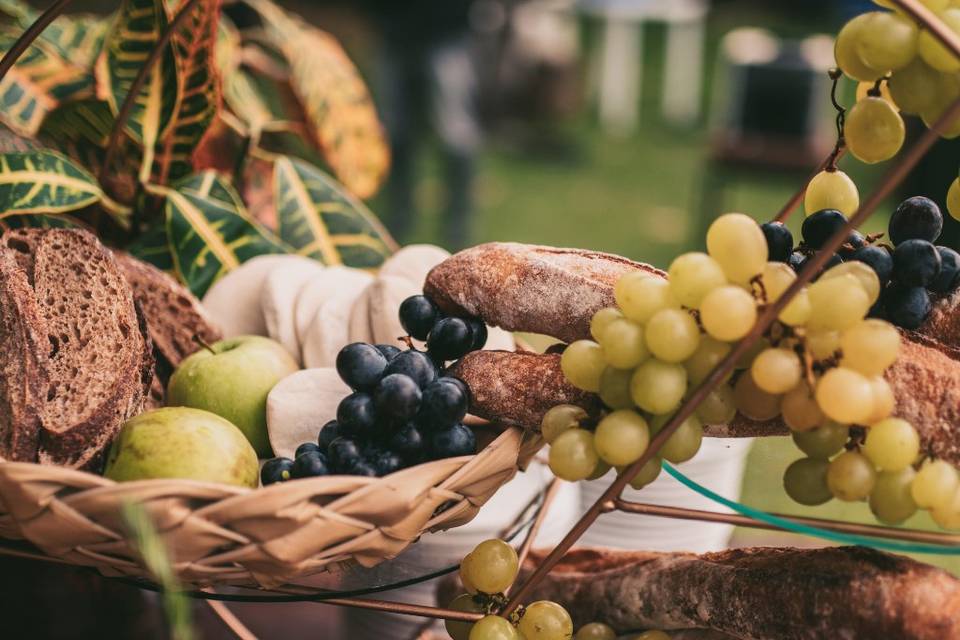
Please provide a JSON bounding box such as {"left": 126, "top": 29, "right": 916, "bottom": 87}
{"left": 97, "top": 0, "right": 180, "bottom": 172}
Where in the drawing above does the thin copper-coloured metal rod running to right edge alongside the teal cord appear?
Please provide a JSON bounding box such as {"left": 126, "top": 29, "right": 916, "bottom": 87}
{"left": 614, "top": 498, "right": 960, "bottom": 547}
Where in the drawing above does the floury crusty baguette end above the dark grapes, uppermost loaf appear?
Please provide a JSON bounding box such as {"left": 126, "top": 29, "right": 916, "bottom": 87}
{"left": 423, "top": 242, "right": 664, "bottom": 342}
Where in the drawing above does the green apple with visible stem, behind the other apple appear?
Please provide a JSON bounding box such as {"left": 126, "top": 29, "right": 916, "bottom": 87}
{"left": 167, "top": 336, "right": 300, "bottom": 458}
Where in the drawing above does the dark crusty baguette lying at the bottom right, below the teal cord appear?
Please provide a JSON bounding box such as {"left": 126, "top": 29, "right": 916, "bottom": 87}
{"left": 520, "top": 547, "right": 960, "bottom": 640}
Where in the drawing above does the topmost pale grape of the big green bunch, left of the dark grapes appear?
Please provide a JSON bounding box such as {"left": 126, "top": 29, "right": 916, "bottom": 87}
{"left": 707, "top": 213, "right": 767, "bottom": 284}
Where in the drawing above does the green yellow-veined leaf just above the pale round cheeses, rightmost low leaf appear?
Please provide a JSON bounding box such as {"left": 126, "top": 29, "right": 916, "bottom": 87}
{"left": 273, "top": 156, "right": 396, "bottom": 268}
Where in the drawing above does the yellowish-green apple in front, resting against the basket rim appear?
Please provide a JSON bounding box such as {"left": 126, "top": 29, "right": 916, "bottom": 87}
{"left": 103, "top": 407, "right": 259, "bottom": 488}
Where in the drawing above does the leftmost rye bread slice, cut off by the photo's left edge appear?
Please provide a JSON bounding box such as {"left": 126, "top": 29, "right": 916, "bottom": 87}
{"left": 0, "top": 248, "right": 48, "bottom": 462}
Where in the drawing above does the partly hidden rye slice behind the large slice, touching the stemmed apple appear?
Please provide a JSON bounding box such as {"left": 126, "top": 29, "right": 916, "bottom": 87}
{"left": 114, "top": 251, "right": 223, "bottom": 400}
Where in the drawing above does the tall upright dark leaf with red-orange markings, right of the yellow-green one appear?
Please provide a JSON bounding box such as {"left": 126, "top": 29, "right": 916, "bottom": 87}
{"left": 153, "top": 0, "right": 221, "bottom": 184}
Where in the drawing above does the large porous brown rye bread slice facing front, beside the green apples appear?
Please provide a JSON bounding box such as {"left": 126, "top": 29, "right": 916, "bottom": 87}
{"left": 3, "top": 229, "right": 153, "bottom": 468}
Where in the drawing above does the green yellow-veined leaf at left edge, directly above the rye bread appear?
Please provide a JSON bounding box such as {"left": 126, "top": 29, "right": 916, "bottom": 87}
{"left": 0, "top": 150, "right": 103, "bottom": 216}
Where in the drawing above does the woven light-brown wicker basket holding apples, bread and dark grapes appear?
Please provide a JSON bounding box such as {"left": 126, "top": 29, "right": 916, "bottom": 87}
{"left": 0, "top": 428, "right": 541, "bottom": 587}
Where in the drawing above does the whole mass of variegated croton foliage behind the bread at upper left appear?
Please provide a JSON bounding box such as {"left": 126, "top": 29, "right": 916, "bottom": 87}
{"left": 0, "top": 0, "right": 395, "bottom": 288}
